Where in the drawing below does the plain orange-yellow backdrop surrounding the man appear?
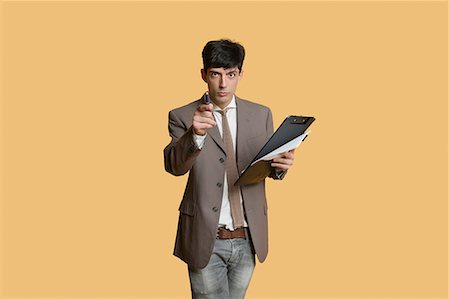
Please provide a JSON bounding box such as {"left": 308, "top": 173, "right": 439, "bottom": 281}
{"left": 0, "top": 1, "right": 448, "bottom": 298}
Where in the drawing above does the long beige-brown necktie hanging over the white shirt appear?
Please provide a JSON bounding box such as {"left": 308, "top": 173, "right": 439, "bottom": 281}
{"left": 219, "top": 108, "right": 244, "bottom": 229}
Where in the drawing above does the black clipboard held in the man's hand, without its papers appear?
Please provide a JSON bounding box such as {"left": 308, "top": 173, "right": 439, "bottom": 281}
{"left": 234, "top": 116, "right": 316, "bottom": 186}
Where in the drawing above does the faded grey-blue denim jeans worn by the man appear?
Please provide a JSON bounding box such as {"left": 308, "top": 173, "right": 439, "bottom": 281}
{"left": 189, "top": 238, "right": 255, "bottom": 299}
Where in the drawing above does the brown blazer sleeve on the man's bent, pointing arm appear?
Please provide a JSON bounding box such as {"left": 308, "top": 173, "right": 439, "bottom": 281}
{"left": 164, "top": 111, "right": 200, "bottom": 176}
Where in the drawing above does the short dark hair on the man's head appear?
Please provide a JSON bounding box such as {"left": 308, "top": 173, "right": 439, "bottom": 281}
{"left": 202, "top": 39, "right": 245, "bottom": 72}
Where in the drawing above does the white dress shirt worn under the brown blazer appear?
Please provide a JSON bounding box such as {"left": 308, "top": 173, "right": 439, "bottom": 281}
{"left": 194, "top": 95, "right": 248, "bottom": 230}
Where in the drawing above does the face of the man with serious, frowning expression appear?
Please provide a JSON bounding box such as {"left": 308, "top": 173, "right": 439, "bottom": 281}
{"left": 202, "top": 67, "right": 242, "bottom": 108}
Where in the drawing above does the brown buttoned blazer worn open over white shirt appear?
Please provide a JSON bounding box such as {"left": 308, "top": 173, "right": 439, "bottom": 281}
{"left": 164, "top": 97, "right": 273, "bottom": 269}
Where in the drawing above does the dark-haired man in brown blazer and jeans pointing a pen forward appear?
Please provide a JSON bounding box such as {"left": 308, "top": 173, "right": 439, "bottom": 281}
{"left": 164, "top": 40, "right": 294, "bottom": 299}
